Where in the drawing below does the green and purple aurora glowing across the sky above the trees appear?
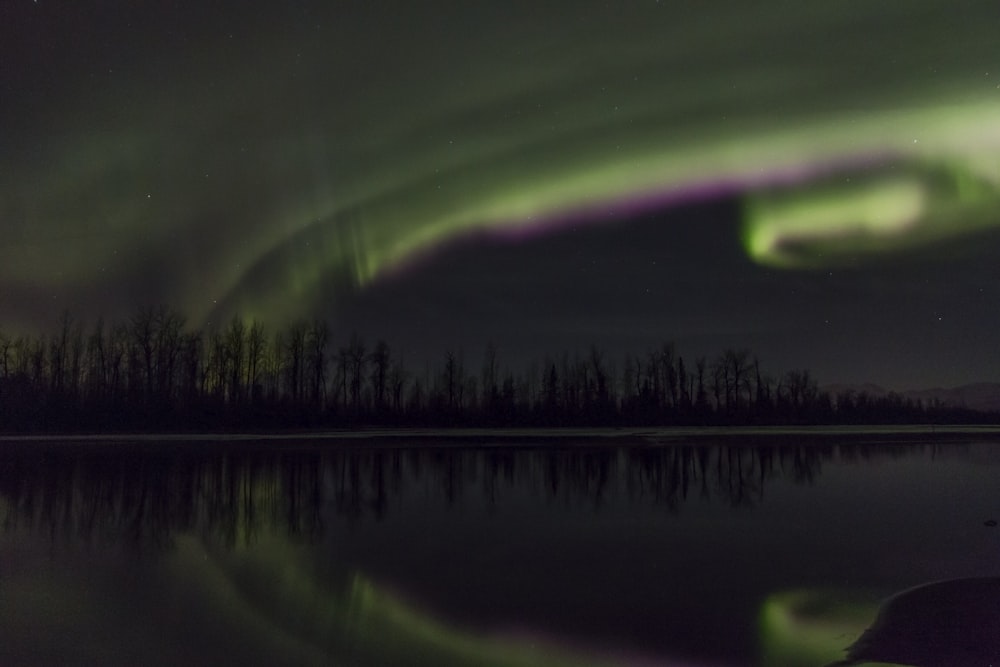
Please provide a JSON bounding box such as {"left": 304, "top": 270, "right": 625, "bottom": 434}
{"left": 0, "top": 0, "right": 1000, "bottom": 325}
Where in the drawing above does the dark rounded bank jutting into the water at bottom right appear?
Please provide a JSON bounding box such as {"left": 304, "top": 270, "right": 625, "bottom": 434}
{"left": 828, "top": 577, "right": 1000, "bottom": 667}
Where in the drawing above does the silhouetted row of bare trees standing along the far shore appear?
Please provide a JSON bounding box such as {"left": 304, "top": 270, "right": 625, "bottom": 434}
{"left": 0, "top": 306, "right": 998, "bottom": 431}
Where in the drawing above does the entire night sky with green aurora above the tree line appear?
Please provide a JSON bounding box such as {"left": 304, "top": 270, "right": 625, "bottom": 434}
{"left": 0, "top": 0, "right": 1000, "bottom": 389}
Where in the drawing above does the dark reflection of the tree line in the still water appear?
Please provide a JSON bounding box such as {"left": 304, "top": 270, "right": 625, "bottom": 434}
{"left": 0, "top": 440, "right": 955, "bottom": 549}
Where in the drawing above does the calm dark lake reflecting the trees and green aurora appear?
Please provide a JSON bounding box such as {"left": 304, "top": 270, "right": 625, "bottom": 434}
{"left": 0, "top": 430, "right": 1000, "bottom": 667}
